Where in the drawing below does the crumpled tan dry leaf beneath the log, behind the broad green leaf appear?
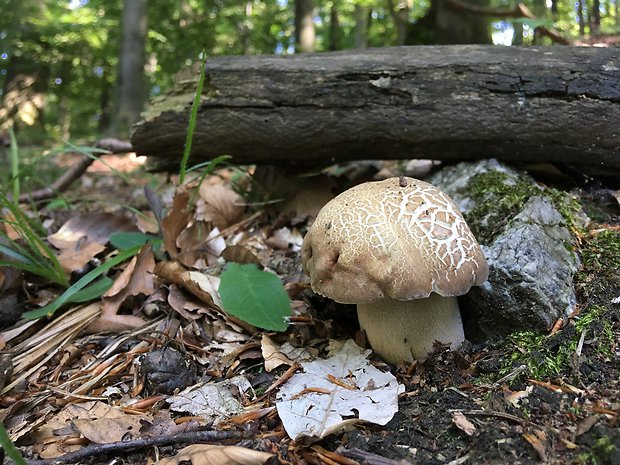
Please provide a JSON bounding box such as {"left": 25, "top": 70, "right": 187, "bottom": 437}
{"left": 196, "top": 183, "right": 245, "bottom": 230}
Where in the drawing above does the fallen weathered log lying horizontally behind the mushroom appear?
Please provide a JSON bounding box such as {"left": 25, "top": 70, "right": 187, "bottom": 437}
{"left": 132, "top": 45, "right": 620, "bottom": 170}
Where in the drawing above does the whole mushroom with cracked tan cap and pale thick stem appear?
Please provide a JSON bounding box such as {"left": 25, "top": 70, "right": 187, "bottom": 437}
{"left": 301, "top": 176, "right": 489, "bottom": 363}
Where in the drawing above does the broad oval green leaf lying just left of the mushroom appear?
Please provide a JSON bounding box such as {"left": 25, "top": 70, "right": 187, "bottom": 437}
{"left": 219, "top": 263, "right": 291, "bottom": 331}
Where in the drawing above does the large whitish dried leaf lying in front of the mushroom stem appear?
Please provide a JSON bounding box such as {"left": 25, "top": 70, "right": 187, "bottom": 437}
{"left": 276, "top": 340, "right": 404, "bottom": 440}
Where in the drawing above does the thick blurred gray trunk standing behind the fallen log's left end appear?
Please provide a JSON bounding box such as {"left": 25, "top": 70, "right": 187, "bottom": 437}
{"left": 111, "top": 0, "right": 147, "bottom": 137}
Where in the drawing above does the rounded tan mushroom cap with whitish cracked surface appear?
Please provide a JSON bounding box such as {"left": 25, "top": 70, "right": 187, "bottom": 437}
{"left": 301, "top": 176, "right": 489, "bottom": 304}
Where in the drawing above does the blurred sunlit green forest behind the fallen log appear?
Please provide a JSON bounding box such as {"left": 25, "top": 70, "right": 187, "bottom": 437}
{"left": 0, "top": 0, "right": 620, "bottom": 154}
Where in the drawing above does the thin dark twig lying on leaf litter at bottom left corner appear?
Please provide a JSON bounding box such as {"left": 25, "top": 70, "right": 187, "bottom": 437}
{"left": 28, "top": 431, "right": 244, "bottom": 465}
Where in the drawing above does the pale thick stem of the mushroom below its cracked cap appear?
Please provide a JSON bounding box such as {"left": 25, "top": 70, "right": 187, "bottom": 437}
{"left": 357, "top": 294, "right": 465, "bottom": 363}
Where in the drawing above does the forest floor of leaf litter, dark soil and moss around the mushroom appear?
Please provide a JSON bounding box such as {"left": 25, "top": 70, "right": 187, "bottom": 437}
{"left": 0, "top": 152, "right": 620, "bottom": 465}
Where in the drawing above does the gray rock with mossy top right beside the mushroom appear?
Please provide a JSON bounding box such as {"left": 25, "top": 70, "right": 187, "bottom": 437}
{"left": 429, "top": 160, "right": 579, "bottom": 336}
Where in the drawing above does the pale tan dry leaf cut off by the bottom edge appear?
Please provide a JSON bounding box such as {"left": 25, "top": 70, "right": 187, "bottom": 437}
{"left": 158, "top": 444, "right": 273, "bottom": 465}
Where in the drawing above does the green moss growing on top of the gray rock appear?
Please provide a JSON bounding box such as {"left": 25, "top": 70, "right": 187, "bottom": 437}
{"left": 465, "top": 171, "right": 582, "bottom": 244}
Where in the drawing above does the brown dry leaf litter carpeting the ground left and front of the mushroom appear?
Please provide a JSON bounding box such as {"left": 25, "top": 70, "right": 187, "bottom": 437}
{"left": 0, "top": 160, "right": 620, "bottom": 464}
